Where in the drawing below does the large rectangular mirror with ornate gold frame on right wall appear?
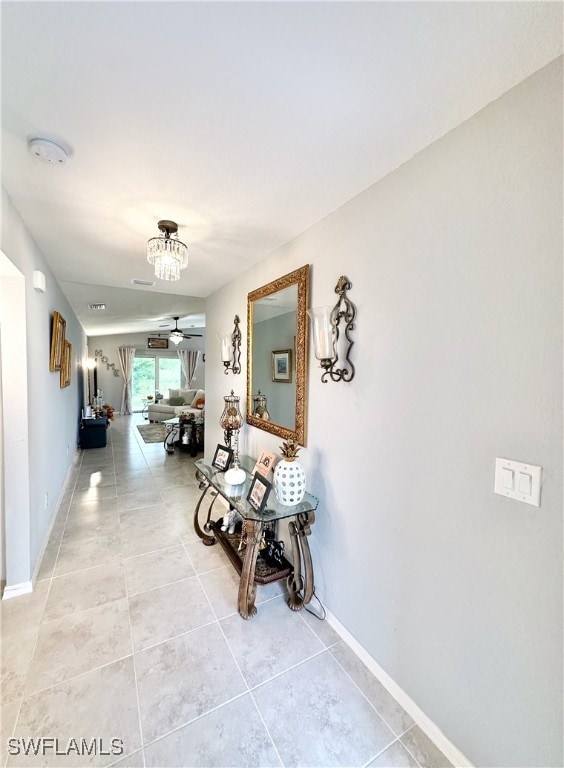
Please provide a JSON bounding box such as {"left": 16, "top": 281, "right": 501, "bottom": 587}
{"left": 247, "top": 264, "right": 309, "bottom": 446}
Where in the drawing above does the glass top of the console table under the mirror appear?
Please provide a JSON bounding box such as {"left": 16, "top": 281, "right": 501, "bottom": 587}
{"left": 194, "top": 456, "right": 319, "bottom": 523}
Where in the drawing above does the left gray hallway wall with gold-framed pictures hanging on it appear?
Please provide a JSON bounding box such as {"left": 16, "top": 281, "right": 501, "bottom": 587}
{"left": 2, "top": 190, "right": 86, "bottom": 585}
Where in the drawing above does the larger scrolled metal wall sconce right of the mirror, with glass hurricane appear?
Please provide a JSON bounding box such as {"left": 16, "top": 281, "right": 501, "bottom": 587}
{"left": 308, "top": 275, "right": 356, "bottom": 384}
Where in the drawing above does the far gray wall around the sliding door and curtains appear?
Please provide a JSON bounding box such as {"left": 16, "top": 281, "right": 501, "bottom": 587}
{"left": 88, "top": 328, "right": 205, "bottom": 411}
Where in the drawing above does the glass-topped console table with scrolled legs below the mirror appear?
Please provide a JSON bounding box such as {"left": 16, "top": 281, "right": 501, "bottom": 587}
{"left": 194, "top": 456, "right": 318, "bottom": 619}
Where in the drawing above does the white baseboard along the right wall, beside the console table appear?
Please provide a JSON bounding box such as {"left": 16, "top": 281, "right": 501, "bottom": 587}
{"left": 325, "top": 608, "right": 474, "bottom": 768}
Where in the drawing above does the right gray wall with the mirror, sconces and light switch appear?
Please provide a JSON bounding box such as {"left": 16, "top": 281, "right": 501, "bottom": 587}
{"left": 206, "top": 60, "right": 563, "bottom": 766}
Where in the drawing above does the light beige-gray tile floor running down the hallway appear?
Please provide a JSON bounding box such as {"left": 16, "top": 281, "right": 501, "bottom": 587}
{"left": 1, "top": 415, "right": 450, "bottom": 768}
